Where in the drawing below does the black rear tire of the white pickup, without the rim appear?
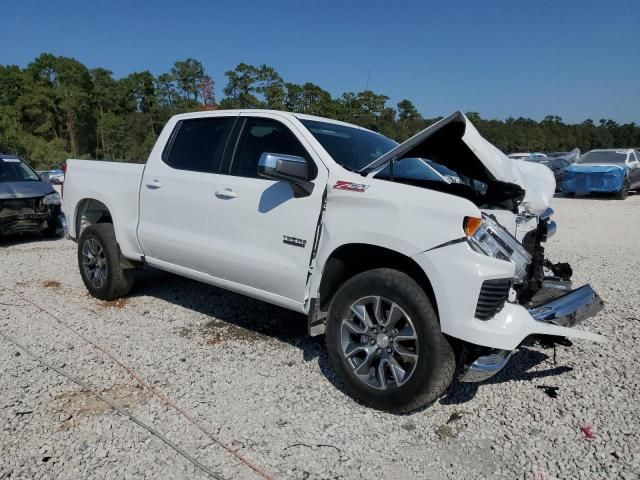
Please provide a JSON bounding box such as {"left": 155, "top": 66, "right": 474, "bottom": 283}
{"left": 78, "top": 223, "right": 134, "bottom": 300}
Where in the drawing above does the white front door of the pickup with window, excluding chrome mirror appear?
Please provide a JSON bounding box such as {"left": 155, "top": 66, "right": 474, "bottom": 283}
{"left": 209, "top": 113, "right": 328, "bottom": 302}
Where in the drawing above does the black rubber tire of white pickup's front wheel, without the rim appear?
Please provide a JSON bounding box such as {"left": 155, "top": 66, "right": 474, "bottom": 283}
{"left": 326, "top": 268, "right": 456, "bottom": 413}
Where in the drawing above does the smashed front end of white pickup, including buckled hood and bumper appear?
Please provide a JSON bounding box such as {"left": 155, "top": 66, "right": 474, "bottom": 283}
{"left": 361, "top": 112, "right": 603, "bottom": 381}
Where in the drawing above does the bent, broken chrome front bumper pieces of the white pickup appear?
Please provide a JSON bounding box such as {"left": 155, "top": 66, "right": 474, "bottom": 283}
{"left": 460, "top": 282, "right": 604, "bottom": 382}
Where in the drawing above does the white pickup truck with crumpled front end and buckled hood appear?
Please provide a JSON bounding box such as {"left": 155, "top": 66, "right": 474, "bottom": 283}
{"left": 63, "top": 110, "right": 602, "bottom": 412}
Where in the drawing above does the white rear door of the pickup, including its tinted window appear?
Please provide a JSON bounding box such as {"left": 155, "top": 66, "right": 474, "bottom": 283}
{"left": 138, "top": 114, "right": 237, "bottom": 273}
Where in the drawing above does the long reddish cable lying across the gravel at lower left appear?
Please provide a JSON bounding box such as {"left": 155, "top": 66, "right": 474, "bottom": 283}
{"left": 0, "top": 285, "right": 273, "bottom": 480}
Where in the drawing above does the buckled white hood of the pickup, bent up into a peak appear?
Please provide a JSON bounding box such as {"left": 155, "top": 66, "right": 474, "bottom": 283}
{"left": 363, "top": 111, "right": 555, "bottom": 214}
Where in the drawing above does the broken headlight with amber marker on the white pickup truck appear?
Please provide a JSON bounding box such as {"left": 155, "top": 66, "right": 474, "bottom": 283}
{"left": 464, "top": 213, "right": 531, "bottom": 282}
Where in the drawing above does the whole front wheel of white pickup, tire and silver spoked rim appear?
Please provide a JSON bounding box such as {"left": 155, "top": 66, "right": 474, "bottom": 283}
{"left": 326, "top": 268, "right": 456, "bottom": 413}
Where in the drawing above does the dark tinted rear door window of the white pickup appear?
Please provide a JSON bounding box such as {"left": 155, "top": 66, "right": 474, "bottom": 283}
{"left": 163, "top": 117, "right": 235, "bottom": 173}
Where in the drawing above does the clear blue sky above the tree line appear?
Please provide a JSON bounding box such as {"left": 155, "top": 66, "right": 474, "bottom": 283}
{"left": 0, "top": 0, "right": 640, "bottom": 123}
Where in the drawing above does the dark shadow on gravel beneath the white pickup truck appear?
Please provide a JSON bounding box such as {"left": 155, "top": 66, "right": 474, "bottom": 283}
{"left": 131, "top": 267, "right": 572, "bottom": 414}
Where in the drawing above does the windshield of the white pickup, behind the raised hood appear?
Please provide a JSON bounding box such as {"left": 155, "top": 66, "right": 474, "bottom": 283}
{"left": 300, "top": 120, "right": 397, "bottom": 171}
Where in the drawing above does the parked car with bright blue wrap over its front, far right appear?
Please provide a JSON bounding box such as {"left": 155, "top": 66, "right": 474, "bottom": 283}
{"left": 562, "top": 148, "right": 640, "bottom": 200}
